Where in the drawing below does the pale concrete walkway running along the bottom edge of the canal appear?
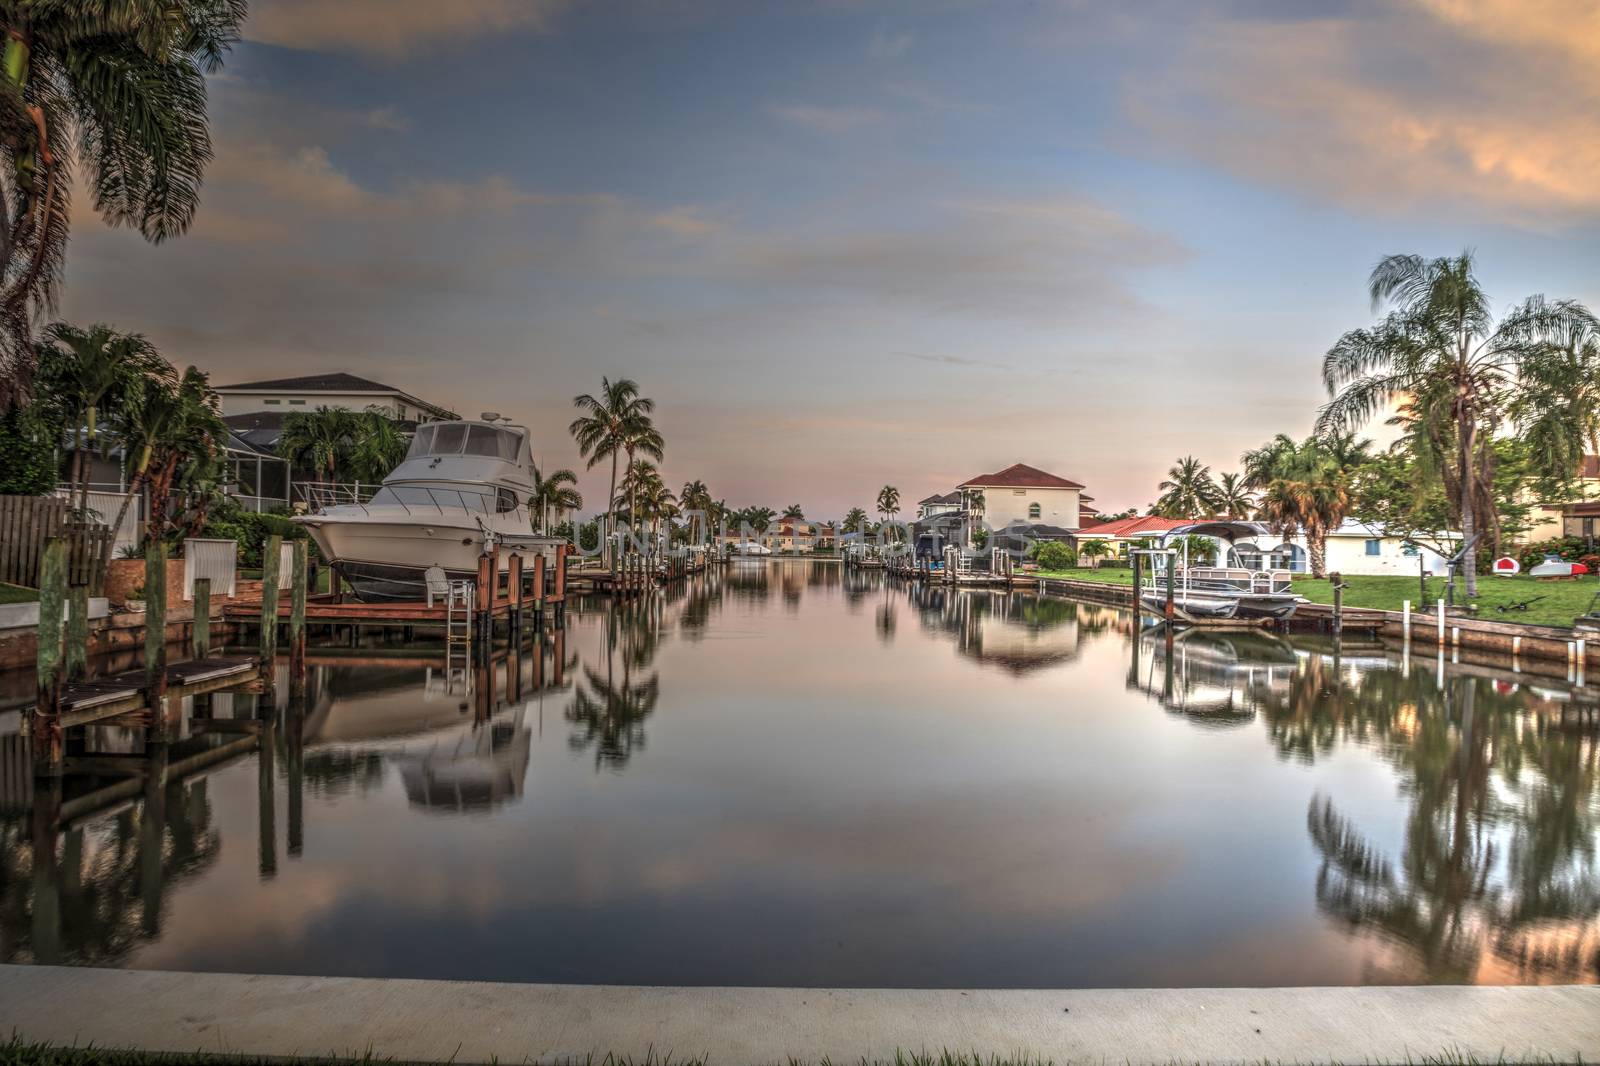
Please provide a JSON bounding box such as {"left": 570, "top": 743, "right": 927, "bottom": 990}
{"left": 0, "top": 967, "right": 1600, "bottom": 1066}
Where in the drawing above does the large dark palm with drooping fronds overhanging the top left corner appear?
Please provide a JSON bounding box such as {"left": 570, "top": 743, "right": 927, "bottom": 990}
{"left": 0, "top": 0, "right": 245, "bottom": 410}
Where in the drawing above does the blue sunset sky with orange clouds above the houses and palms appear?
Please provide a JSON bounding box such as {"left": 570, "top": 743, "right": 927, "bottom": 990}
{"left": 61, "top": 0, "right": 1600, "bottom": 517}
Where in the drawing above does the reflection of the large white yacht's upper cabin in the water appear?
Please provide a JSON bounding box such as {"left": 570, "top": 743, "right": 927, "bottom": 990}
{"left": 400, "top": 707, "right": 533, "bottom": 812}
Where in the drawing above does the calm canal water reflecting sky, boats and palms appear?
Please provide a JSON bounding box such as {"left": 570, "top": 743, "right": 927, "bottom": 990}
{"left": 0, "top": 562, "right": 1600, "bottom": 988}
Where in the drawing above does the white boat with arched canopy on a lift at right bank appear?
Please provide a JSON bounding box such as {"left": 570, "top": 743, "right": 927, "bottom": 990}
{"left": 1139, "top": 522, "right": 1306, "bottom": 619}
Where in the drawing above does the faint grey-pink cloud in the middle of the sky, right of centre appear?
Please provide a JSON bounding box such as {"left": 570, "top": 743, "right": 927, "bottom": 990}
{"left": 741, "top": 195, "right": 1187, "bottom": 322}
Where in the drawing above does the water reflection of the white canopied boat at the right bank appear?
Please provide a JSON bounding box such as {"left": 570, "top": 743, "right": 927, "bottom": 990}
{"left": 1133, "top": 629, "right": 1299, "bottom": 725}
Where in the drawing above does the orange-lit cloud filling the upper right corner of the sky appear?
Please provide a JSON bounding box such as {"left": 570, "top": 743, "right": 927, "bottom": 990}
{"left": 1126, "top": 0, "right": 1600, "bottom": 224}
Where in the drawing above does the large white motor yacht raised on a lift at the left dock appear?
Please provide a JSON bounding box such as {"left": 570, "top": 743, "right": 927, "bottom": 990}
{"left": 294, "top": 413, "right": 562, "bottom": 602}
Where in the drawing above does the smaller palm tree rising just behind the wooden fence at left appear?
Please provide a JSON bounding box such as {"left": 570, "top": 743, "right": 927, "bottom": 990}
{"left": 38, "top": 322, "right": 164, "bottom": 514}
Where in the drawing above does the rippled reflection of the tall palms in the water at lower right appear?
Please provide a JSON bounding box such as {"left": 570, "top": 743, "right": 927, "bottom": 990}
{"left": 1307, "top": 671, "right": 1600, "bottom": 981}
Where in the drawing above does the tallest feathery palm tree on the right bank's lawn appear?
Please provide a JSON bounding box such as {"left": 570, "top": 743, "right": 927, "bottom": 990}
{"left": 1317, "top": 251, "right": 1595, "bottom": 597}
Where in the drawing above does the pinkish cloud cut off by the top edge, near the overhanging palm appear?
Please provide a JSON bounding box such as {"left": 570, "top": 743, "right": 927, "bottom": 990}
{"left": 245, "top": 0, "right": 570, "bottom": 58}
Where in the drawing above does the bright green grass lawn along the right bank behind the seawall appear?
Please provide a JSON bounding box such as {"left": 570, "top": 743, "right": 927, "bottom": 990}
{"left": 1040, "top": 570, "right": 1600, "bottom": 626}
